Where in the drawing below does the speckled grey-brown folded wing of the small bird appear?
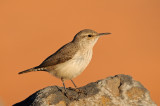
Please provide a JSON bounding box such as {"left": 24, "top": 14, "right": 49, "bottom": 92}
{"left": 38, "top": 42, "right": 78, "bottom": 68}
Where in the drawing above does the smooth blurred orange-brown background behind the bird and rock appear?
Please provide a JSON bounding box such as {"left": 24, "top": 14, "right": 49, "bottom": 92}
{"left": 0, "top": 0, "right": 160, "bottom": 106}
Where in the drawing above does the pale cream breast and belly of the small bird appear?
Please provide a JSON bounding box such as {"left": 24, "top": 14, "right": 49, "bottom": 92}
{"left": 52, "top": 49, "right": 92, "bottom": 79}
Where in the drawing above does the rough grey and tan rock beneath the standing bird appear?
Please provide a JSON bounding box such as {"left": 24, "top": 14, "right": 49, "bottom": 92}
{"left": 14, "top": 74, "right": 157, "bottom": 106}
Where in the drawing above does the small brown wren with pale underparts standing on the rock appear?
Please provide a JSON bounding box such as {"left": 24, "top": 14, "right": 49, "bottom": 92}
{"left": 19, "top": 29, "right": 110, "bottom": 91}
